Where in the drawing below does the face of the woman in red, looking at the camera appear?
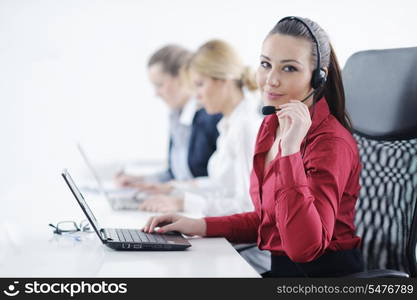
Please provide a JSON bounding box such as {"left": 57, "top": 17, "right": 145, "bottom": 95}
{"left": 256, "top": 34, "right": 313, "bottom": 107}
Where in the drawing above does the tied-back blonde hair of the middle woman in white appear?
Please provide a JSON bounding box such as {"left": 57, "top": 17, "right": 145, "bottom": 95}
{"left": 188, "top": 40, "right": 258, "bottom": 91}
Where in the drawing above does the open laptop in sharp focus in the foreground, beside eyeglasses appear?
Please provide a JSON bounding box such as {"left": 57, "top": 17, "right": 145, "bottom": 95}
{"left": 61, "top": 170, "right": 191, "bottom": 250}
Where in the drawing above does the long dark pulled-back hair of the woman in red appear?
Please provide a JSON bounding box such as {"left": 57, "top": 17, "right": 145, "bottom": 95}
{"left": 268, "top": 18, "right": 352, "bottom": 132}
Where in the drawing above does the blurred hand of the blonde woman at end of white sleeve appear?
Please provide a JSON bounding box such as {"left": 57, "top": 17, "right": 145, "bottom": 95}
{"left": 139, "top": 195, "right": 184, "bottom": 212}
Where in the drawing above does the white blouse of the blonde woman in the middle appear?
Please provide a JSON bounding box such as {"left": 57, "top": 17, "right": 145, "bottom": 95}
{"left": 176, "top": 98, "right": 262, "bottom": 216}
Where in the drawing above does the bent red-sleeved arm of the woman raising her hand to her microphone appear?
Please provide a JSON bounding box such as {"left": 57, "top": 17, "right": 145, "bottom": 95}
{"left": 275, "top": 138, "right": 355, "bottom": 262}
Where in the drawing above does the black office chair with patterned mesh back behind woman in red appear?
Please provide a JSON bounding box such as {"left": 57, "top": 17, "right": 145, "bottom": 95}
{"left": 343, "top": 47, "right": 417, "bottom": 277}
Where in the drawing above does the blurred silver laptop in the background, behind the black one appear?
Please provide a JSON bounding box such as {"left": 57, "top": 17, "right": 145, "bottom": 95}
{"left": 77, "top": 144, "right": 148, "bottom": 210}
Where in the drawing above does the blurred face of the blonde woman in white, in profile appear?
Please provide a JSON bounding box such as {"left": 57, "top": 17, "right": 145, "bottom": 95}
{"left": 191, "top": 72, "right": 225, "bottom": 114}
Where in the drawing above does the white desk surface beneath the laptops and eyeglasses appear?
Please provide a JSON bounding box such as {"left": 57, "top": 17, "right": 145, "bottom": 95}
{"left": 0, "top": 179, "right": 260, "bottom": 277}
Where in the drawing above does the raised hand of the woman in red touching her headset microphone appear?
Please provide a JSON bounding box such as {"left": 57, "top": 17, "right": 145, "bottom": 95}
{"left": 277, "top": 100, "right": 311, "bottom": 156}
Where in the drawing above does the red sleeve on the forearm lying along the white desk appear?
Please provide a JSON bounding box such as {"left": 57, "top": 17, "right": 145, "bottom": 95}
{"left": 204, "top": 212, "right": 260, "bottom": 243}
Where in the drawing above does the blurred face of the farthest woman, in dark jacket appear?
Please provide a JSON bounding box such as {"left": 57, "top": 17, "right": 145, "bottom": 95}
{"left": 148, "top": 63, "right": 188, "bottom": 109}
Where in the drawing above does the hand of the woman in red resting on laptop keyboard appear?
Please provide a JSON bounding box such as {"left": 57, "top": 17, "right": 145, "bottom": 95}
{"left": 142, "top": 214, "right": 207, "bottom": 236}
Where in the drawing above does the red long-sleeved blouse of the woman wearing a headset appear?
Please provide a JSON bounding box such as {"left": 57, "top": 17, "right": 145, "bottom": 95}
{"left": 205, "top": 98, "right": 361, "bottom": 262}
